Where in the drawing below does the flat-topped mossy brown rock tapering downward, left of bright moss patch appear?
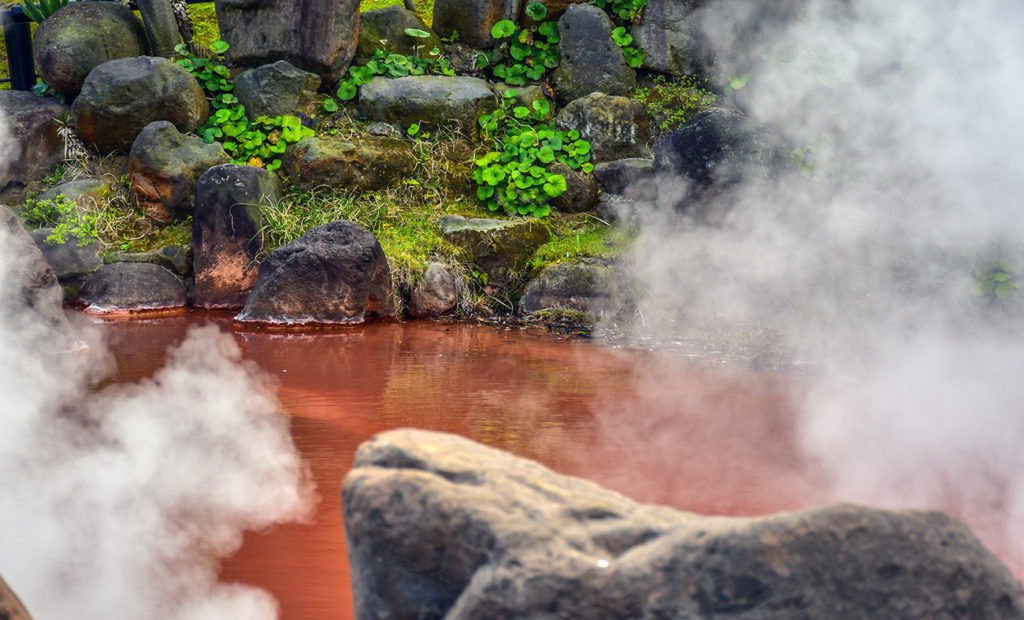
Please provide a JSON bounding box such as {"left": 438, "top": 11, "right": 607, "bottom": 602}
{"left": 440, "top": 215, "right": 551, "bottom": 289}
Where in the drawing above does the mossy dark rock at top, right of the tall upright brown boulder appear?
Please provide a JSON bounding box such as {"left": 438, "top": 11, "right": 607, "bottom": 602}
{"left": 352, "top": 4, "right": 444, "bottom": 65}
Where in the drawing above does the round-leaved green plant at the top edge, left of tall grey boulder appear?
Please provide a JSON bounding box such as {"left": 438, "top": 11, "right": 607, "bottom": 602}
{"left": 476, "top": 2, "right": 561, "bottom": 86}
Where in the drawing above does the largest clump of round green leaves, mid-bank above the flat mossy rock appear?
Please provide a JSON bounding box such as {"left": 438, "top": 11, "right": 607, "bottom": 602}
{"left": 472, "top": 89, "right": 594, "bottom": 217}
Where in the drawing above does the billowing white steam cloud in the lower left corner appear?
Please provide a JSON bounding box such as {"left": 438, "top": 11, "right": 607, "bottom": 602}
{"left": 0, "top": 107, "right": 313, "bottom": 620}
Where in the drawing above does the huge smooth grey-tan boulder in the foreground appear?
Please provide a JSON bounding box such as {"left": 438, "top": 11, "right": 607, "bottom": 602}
{"left": 342, "top": 429, "right": 1024, "bottom": 620}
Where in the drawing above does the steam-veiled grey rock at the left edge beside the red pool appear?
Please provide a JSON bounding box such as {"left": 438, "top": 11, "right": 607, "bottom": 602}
{"left": 0, "top": 206, "right": 74, "bottom": 352}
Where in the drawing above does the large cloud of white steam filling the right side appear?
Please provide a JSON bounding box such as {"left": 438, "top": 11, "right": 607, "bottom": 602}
{"left": 618, "top": 0, "right": 1024, "bottom": 567}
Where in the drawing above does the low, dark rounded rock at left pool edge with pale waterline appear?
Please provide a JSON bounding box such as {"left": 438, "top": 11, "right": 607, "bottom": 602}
{"left": 77, "top": 262, "right": 186, "bottom": 315}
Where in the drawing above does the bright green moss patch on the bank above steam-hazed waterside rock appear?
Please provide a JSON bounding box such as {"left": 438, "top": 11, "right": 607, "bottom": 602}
{"left": 529, "top": 213, "right": 635, "bottom": 271}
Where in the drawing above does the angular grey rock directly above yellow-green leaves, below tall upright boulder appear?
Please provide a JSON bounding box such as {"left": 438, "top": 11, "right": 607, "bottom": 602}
{"left": 232, "top": 60, "right": 321, "bottom": 119}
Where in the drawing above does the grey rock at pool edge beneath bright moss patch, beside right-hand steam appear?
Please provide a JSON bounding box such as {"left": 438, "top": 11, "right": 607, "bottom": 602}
{"left": 519, "top": 258, "right": 622, "bottom": 315}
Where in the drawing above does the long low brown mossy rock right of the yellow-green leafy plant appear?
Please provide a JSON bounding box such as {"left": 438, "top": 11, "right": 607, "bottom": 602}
{"left": 282, "top": 136, "right": 416, "bottom": 191}
